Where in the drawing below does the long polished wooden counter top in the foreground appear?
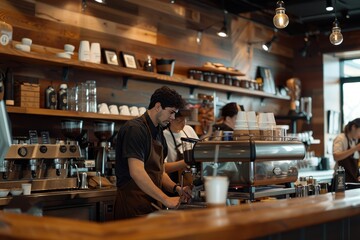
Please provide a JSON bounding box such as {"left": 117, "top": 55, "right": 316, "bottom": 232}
{"left": 0, "top": 189, "right": 360, "bottom": 240}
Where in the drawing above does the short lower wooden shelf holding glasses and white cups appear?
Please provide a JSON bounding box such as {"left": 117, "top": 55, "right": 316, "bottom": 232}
{"left": 6, "top": 106, "right": 134, "bottom": 121}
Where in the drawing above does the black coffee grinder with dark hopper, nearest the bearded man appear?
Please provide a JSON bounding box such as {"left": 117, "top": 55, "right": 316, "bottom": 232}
{"left": 89, "top": 121, "right": 115, "bottom": 176}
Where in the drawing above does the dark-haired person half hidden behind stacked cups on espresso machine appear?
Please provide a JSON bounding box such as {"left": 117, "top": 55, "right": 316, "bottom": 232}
{"left": 213, "top": 102, "right": 241, "bottom": 131}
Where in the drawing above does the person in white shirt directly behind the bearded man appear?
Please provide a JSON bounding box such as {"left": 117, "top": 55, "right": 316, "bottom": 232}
{"left": 164, "top": 109, "right": 198, "bottom": 182}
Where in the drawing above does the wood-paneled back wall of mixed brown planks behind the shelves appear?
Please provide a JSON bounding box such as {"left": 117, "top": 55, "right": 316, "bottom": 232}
{"left": 0, "top": 0, "right": 294, "bottom": 139}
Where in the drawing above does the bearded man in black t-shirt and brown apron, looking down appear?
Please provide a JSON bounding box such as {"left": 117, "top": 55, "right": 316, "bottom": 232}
{"left": 115, "top": 86, "right": 191, "bottom": 219}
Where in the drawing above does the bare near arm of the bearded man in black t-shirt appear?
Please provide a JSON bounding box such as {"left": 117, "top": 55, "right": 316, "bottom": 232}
{"left": 128, "top": 158, "right": 180, "bottom": 208}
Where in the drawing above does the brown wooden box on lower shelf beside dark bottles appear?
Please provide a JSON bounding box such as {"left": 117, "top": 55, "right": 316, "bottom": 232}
{"left": 15, "top": 83, "right": 40, "bottom": 108}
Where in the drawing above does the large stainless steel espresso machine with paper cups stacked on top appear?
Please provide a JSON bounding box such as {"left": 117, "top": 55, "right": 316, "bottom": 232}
{"left": 182, "top": 137, "right": 306, "bottom": 201}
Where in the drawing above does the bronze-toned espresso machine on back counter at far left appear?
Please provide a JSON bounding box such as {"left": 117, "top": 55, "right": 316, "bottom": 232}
{"left": 0, "top": 143, "right": 81, "bottom": 191}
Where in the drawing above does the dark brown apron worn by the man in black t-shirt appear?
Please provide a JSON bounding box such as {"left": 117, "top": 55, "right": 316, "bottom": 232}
{"left": 115, "top": 115, "right": 164, "bottom": 219}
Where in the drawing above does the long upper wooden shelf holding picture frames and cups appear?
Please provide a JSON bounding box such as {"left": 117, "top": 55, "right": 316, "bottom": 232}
{"left": 0, "top": 42, "right": 290, "bottom": 100}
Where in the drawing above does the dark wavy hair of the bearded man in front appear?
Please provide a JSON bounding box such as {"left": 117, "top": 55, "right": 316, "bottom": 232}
{"left": 149, "top": 86, "right": 185, "bottom": 109}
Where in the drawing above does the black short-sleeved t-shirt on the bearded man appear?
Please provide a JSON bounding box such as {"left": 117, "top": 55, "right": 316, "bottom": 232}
{"left": 115, "top": 112, "right": 167, "bottom": 187}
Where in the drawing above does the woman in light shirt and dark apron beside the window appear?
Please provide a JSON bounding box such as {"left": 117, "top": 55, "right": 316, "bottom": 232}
{"left": 333, "top": 118, "right": 360, "bottom": 182}
